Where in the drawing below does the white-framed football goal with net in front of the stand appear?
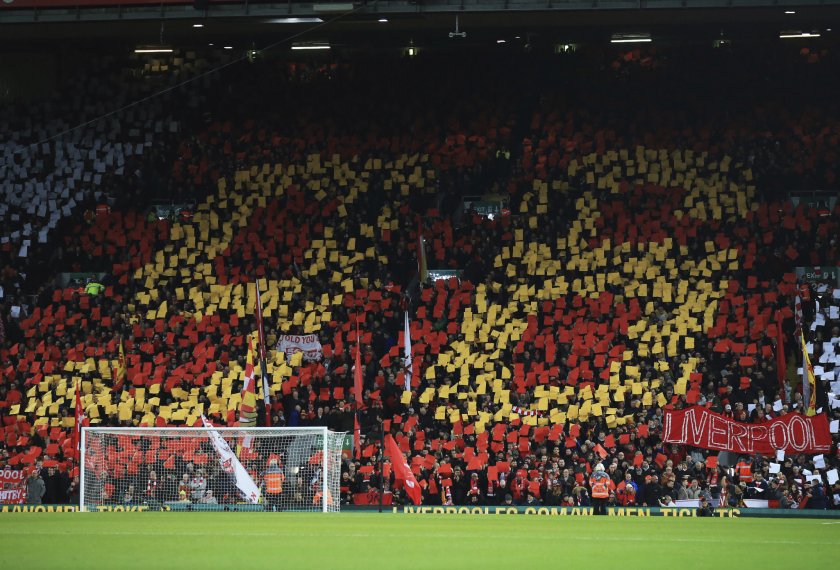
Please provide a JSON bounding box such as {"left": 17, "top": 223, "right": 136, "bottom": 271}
{"left": 79, "top": 424, "right": 344, "bottom": 512}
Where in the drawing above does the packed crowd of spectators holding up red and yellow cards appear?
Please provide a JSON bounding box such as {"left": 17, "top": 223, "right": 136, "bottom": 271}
{"left": 0, "top": 43, "right": 840, "bottom": 508}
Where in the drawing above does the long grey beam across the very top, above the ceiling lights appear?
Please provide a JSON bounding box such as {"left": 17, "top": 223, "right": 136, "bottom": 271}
{"left": 0, "top": 0, "right": 840, "bottom": 24}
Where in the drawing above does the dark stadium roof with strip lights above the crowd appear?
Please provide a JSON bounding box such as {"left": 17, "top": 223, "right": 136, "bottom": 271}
{"left": 0, "top": 0, "right": 840, "bottom": 48}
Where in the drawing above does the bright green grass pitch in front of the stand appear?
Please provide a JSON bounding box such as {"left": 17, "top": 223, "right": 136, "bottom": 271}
{"left": 0, "top": 513, "right": 840, "bottom": 570}
